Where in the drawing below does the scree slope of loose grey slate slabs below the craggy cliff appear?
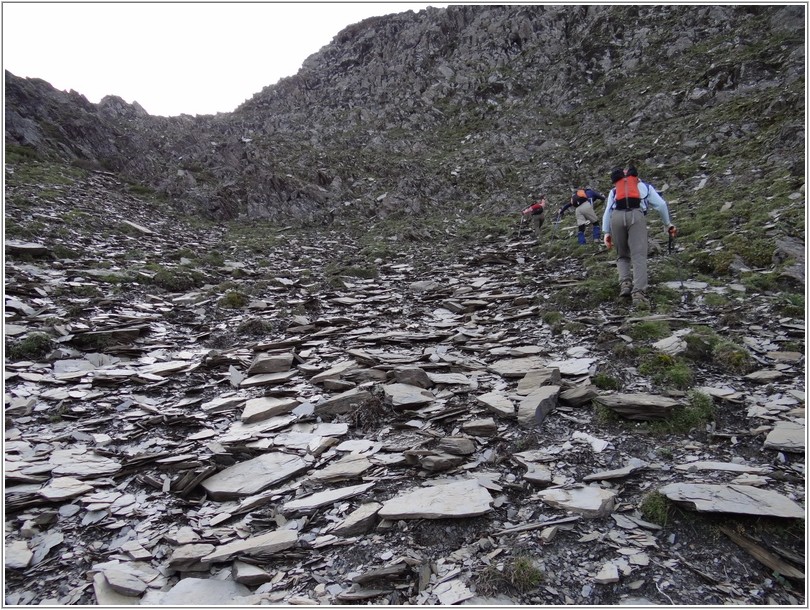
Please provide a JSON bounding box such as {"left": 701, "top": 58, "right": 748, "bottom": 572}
{"left": 4, "top": 163, "right": 805, "bottom": 606}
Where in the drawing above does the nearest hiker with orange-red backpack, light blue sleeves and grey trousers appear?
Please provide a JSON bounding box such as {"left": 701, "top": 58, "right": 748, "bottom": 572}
{"left": 602, "top": 165, "right": 677, "bottom": 306}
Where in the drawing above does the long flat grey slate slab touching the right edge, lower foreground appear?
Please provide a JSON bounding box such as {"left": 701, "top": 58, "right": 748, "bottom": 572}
{"left": 658, "top": 483, "right": 804, "bottom": 519}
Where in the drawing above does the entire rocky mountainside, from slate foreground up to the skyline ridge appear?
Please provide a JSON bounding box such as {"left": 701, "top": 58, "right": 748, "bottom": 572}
{"left": 4, "top": 6, "right": 806, "bottom": 605}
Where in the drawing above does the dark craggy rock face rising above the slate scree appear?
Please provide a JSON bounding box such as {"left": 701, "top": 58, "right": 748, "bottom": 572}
{"left": 6, "top": 6, "right": 805, "bottom": 222}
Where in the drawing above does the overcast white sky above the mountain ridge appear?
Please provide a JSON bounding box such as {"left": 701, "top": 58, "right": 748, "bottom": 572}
{"left": 2, "top": 2, "right": 447, "bottom": 116}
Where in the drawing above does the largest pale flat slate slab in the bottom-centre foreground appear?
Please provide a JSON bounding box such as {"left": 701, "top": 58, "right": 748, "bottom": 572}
{"left": 379, "top": 479, "right": 492, "bottom": 519}
